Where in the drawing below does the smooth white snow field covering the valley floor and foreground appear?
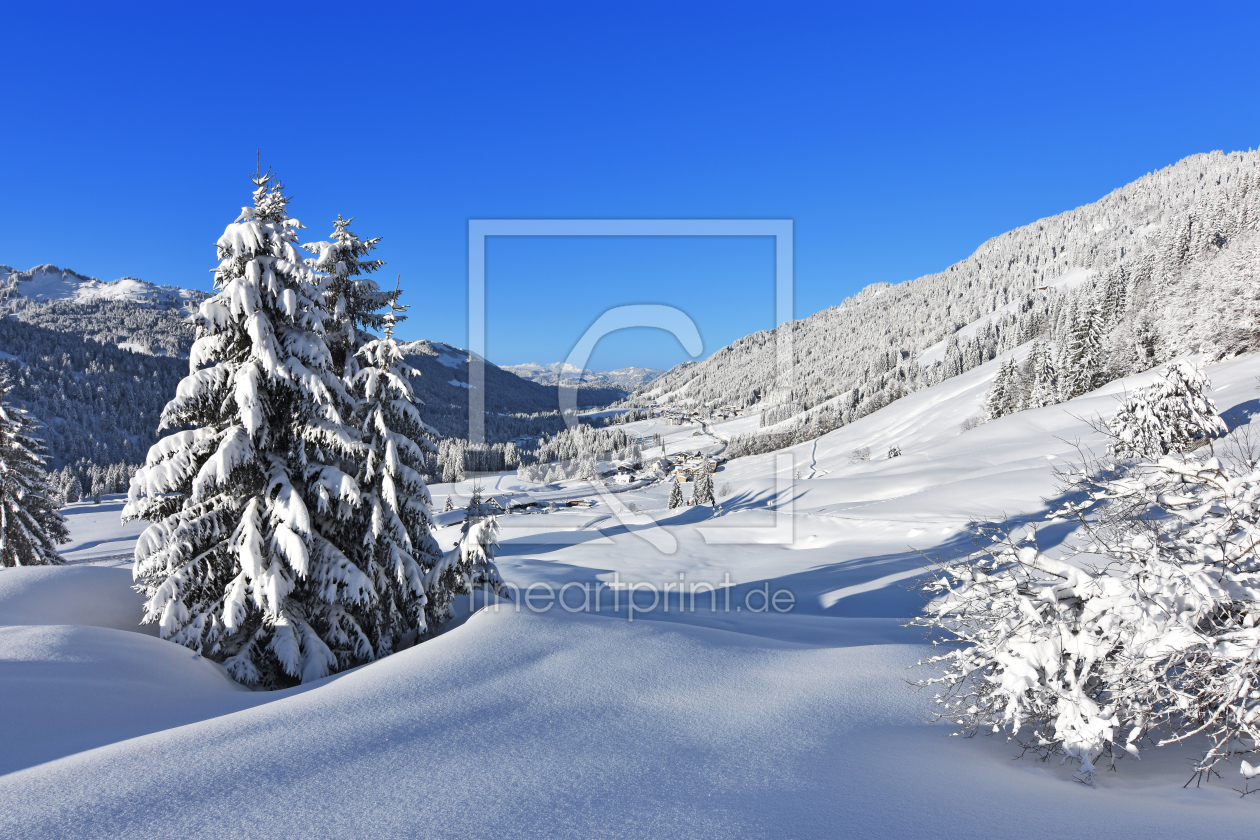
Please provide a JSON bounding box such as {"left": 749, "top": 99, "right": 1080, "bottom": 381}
{"left": 0, "top": 356, "right": 1260, "bottom": 837}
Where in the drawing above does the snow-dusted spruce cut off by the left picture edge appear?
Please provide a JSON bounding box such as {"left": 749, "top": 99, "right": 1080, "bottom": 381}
{"left": 0, "top": 373, "right": 69, "bottom": 567}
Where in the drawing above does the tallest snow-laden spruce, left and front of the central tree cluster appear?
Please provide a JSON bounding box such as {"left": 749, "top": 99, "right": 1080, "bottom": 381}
{"left": 122, "top": 173, "right": 379, "bottom": 688}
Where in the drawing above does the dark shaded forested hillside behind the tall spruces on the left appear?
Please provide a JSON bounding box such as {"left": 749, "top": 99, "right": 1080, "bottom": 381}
{"left": 0, "top": 292, "right": 622, "bottom": 496}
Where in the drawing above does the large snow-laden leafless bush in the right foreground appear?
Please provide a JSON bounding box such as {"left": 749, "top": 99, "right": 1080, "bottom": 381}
{"left": 912, "top": 437, "right": 1260, "bottom": 783}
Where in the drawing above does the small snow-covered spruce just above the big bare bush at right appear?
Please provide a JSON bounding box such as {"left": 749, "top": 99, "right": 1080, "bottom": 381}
{"left": 1106, "top": 361, "right": 1227, "bottom": 458}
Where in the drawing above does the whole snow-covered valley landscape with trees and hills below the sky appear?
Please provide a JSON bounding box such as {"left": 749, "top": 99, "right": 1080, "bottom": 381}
{"left": 7, "top": 146, "right": 1260, "bottom": 839}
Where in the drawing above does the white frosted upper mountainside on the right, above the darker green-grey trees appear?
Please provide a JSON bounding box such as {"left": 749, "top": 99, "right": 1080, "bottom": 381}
{"left": 631, "top": 150, "right": 1260, "bottom": 421}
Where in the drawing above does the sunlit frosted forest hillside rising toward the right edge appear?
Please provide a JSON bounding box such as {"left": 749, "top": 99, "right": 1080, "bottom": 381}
{"left": 626, "top": 151, "right": 1260, "bottom": 445}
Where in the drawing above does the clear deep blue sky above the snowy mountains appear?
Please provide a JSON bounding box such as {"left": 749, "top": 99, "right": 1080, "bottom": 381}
{"left": 0, "top": 3, "right": 1260, "bottom": 369}
